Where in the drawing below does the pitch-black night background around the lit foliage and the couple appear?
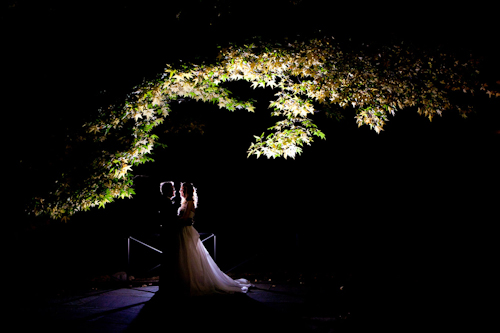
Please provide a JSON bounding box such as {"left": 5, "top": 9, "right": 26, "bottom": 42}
{"left": 4, "top": 0, "right": 500, "bottom": 330}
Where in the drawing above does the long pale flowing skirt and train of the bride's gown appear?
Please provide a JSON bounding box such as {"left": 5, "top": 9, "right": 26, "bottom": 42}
{"left": 176, "top": 226, "right": 251, "bottom": 296}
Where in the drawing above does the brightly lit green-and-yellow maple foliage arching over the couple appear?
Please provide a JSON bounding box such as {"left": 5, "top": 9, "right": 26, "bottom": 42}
{"left": 28, "top": 38, "right": 500, "bottom": 220}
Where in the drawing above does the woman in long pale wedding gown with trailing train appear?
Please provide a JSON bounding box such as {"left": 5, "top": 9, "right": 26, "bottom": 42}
{"left": 175, "top": 183, "right": 251, "bottom": 296}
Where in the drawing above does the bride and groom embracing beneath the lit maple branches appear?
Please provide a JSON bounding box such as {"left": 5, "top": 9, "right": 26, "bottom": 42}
{"left": 160, "top": 182, "right": 251, "bottom": 296}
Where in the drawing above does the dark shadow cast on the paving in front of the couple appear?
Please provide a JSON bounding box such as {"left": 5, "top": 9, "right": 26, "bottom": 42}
{"left": 126, "top": 292, "right": 307, "bottom": 332}
